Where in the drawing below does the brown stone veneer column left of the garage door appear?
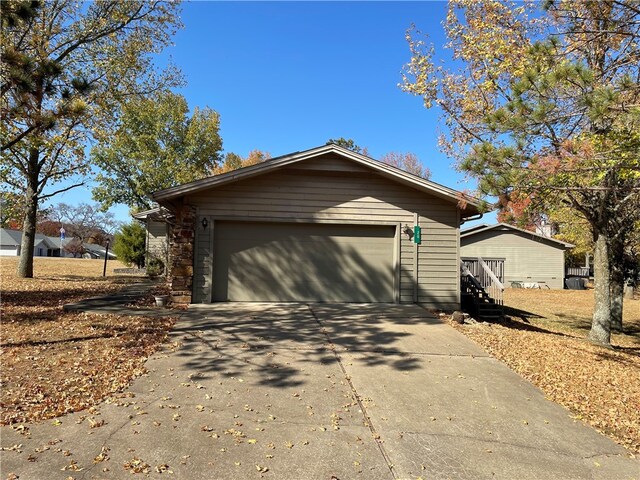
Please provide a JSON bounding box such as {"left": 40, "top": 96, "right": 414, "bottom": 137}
{"left": 169, "top": 205, "right": 196, "bottom": 305}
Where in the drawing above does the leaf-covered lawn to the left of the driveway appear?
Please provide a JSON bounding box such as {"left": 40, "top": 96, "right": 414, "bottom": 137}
{"left": 0, "top": 257, "right": 174, "bottom": 424}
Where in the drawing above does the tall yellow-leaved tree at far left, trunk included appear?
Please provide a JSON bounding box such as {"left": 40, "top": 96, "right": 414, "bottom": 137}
{"left": 0, "top": 0, "right": 181, "bottom": 277}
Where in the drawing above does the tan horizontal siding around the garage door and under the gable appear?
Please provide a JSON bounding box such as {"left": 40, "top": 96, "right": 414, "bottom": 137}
{"left": 186, "top": 157, "right": 459, "bottom": 308}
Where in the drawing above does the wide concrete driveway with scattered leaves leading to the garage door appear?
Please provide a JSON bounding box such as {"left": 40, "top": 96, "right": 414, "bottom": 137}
{"left": 1, "top": 304, "right": 640, "bottom": 480}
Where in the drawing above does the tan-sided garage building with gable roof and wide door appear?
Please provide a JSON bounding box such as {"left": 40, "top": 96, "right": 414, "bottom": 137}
{"left": 153, "top": 144, "right": 480, "bottom": 309}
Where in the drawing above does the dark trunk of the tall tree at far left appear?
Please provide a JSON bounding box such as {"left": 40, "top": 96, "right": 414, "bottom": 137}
{"left": 18, "top": 148, "right": 40, "bottom": 278}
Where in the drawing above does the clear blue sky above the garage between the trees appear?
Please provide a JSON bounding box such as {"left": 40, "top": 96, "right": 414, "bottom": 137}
{"left": 52, "top": 1, "right": 496, "bottom": 225}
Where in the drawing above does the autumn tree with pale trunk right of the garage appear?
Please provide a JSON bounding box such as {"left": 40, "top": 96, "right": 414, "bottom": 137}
{"left": 402, "top": 0, "right": 640, "bottom": 345}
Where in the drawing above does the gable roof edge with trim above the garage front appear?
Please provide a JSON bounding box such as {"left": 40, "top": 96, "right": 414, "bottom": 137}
{"left": 153, "top": 144, "right": 482, "bottom": 217}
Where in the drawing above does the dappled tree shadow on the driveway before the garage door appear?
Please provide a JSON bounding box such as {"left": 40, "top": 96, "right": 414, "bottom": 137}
{"left": 169, "top": 303, "right": 442, "bottom": 387}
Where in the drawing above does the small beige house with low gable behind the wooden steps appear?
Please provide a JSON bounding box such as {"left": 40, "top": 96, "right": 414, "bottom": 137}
{"left": 460, "top": 223, "right": 573, "bottom": 289}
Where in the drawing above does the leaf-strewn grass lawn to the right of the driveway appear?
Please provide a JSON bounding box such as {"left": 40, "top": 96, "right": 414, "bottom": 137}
{"left": 453, "top": 289, "right": 640, "bottom": 452}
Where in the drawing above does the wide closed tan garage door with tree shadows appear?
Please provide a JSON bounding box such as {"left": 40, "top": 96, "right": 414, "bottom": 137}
{"left": 213, "top": 221, "right": 396, "bottom": 302}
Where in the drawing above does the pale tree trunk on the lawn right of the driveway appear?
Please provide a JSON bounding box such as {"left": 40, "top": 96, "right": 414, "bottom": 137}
{"left": 589, "top": 233, "right": 611, "bottom": 346}
